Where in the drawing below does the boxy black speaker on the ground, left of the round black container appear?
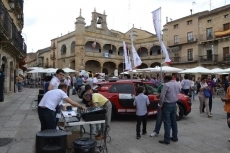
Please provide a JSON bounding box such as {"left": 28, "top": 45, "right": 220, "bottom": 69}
{"left": 36, "top": 129, "right": 67, "bottom": 153}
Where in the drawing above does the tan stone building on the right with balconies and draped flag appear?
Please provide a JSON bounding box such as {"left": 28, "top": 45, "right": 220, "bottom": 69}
{"left": 163, "top": 5, "right": 230, "bottom": 69}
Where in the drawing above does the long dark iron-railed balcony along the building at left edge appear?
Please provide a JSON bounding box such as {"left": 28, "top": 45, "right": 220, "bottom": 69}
{"left": 0, "top": 2, "right": 27, "bottom": 55}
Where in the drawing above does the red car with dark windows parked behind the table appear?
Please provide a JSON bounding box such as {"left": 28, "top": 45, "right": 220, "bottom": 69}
{"left": 97, "top": 80, "right": 192, "bottom": 120}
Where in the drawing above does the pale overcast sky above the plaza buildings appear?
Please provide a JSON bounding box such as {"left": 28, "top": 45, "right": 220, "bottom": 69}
{"left": 22, "top": 0, "right": 230, "bottom": 52}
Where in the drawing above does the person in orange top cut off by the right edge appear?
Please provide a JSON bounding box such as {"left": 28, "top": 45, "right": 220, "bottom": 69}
{"left": 221, "top": 82, "right": 230, "bottom": 142}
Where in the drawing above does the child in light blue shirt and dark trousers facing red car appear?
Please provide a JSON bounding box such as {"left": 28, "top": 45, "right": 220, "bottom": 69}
{"left": 133, "top": 86, "right": 149, "bottom": 139}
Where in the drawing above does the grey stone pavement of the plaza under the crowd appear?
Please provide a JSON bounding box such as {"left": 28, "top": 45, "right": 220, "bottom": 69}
{"left": 0, "top": 89, "right": 230, "bottom": 153}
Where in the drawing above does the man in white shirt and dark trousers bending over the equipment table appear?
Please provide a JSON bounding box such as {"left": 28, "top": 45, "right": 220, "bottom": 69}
{"left": 38, "top": 84, "right": 87, "bottom": 131}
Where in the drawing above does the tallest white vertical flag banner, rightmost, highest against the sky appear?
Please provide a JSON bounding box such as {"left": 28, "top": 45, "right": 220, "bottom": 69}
{"left": 152, "top": 8, "right": 171, "bottom": 63}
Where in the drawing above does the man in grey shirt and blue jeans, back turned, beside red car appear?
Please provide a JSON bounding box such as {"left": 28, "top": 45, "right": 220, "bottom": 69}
{"left": 159, "top": 75, "right": 180, "bottom": 144}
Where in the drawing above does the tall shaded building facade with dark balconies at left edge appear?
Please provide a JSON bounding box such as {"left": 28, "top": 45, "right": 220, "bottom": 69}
{"left": 0, "top": 0, "right": 26, "bottom": 93}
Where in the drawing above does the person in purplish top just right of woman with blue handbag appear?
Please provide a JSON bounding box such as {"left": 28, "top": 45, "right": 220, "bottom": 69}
{"left": 202, "top": 75, "right": 215, "bottom": 115}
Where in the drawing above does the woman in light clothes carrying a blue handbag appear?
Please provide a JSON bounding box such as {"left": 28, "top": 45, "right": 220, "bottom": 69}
{"left": 197, "top": 77, "right": 212, "bottom": 117}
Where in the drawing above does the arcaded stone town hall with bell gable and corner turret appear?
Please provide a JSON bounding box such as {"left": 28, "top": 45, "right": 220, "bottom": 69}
{"left": 50, "top": 10, "right": 161, "bottom": 75}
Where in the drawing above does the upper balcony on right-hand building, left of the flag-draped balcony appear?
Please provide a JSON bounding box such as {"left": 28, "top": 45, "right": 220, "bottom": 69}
{"left": 167, "top": 35, "right": 198, "bottom": 47}
